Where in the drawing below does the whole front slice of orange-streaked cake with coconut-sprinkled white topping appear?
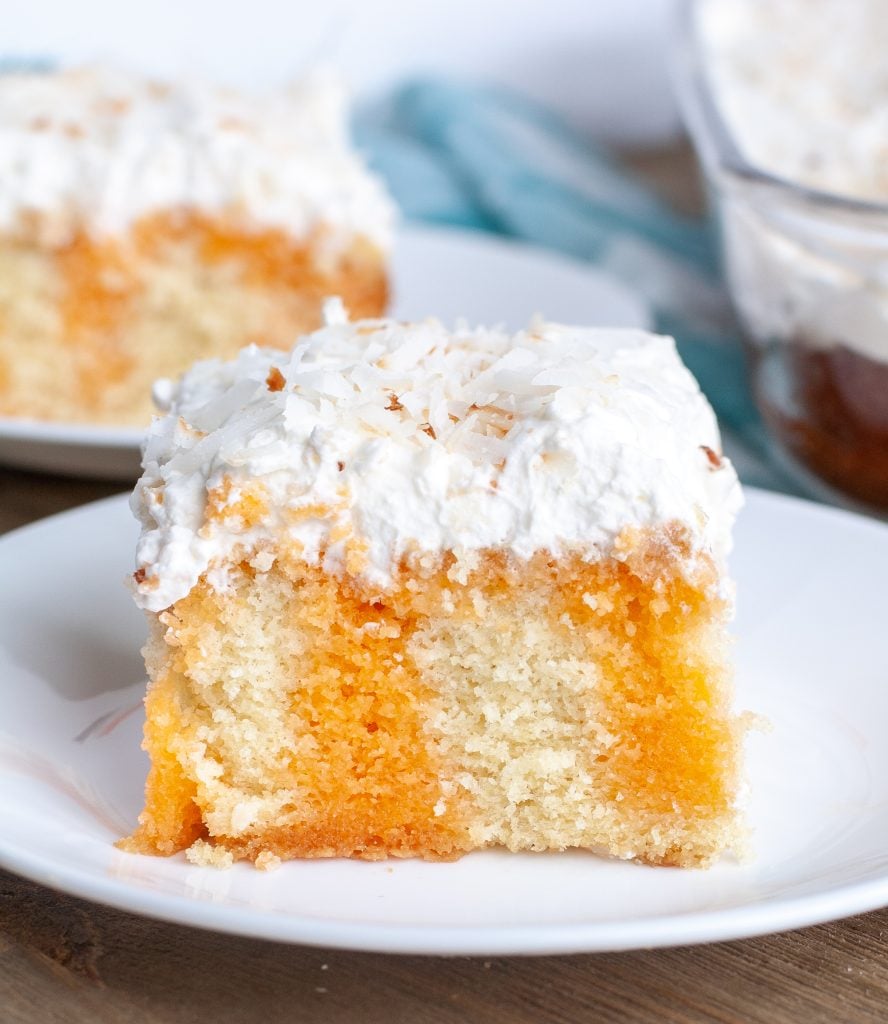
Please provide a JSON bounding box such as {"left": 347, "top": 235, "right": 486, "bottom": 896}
{"left": 126, "top": 307, "right": 743, "bottom": 865}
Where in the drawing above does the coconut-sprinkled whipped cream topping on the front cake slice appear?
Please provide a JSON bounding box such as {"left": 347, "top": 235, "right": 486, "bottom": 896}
{"left": 132, "top": 304, "right": 741, "bottom": 611}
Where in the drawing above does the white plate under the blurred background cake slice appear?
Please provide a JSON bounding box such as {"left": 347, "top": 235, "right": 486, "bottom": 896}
{"left": 0, "top": 227, "right": 649, "bottom": 480}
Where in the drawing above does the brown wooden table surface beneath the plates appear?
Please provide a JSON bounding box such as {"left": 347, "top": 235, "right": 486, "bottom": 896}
{"left": 0, "top": 151, "right": 888, "bottom": 1024}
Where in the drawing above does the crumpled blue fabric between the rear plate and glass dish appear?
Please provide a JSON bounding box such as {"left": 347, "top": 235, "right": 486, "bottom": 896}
{"left": 355, "top": 80, "right": 802, "bottom": 494}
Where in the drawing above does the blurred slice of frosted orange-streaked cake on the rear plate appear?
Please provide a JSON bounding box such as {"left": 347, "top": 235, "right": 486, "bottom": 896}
{"left": 0, "top": 69, "right": 392, "bottom": 425}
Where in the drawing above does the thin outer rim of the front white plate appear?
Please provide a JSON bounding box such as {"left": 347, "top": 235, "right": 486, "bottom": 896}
{"left": 0, "top": 487, "right": 888, "bottom": 955}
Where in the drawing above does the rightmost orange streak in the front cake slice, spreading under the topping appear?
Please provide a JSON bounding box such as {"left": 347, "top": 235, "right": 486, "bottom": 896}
{"left": 409, "top": 544, "right": 739, "bottom": 863}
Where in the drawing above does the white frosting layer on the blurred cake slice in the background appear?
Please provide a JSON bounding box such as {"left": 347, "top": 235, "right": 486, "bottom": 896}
{"left": 0, "top": 68, "right": 393, "bottom": 248}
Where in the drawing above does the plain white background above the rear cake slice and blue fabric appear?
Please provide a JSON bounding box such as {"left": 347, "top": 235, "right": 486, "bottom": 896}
{"left": 0, "top": 0, "right": 678, "bottom": 141}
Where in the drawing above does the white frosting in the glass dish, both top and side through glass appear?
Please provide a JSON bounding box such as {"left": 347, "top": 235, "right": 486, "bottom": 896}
{"left": 699, "top": 0, "right": 888, "bottom": 361}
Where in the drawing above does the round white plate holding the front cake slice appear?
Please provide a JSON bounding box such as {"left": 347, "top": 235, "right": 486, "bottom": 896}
{"left": 0, "top": 492, "right": 888, "bottom": 954}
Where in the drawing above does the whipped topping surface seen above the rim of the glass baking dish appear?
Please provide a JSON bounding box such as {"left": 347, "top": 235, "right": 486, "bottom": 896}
{"left": 700, "top": 0, "right": 888, "bottom": 202}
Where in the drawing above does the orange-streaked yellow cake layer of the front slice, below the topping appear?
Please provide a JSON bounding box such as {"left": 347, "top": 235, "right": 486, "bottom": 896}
{"left": 129, "top": 530, "right": 747, "bottom": 868}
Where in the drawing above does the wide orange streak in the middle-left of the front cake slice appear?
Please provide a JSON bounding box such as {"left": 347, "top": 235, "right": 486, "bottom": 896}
{"left": 268, "top": 566, "right": 461, "bottom": 859}
